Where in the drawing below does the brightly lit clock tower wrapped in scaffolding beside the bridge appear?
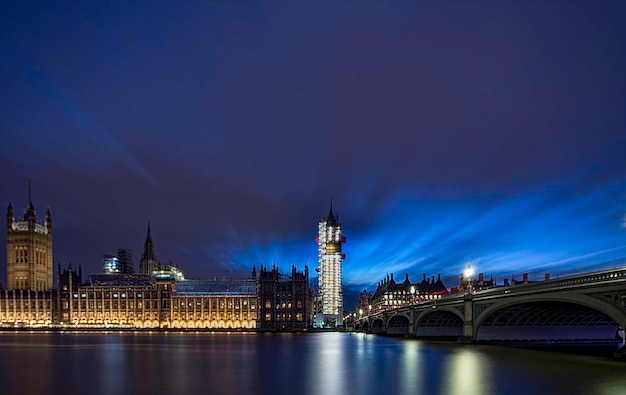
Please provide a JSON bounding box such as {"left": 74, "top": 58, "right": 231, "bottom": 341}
{"left": 316, "top": 199, "right": 346, "bottom": 327}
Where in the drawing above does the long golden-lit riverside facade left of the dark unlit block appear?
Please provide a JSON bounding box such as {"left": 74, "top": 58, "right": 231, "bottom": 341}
{"left": 0, "top": 283, "right": 258, "bottom": 330}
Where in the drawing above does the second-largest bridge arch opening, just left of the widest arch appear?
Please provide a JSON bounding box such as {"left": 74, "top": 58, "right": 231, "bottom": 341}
{"left": 415, "top": 307, "right": 464, "bottom": 337}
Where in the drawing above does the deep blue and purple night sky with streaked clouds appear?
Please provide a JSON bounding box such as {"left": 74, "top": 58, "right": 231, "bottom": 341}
{"left": 0, "top": 1, "right": 626, "bottom": 310}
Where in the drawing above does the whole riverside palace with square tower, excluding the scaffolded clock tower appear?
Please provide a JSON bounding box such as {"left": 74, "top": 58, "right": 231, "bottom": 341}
{"left": 0, "top": 198, "right": 313, "bottom": 331}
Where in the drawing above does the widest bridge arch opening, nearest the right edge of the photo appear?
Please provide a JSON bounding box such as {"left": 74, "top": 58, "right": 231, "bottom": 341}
{"left": 473, "top": 294, "right": 625, "bottom": 341}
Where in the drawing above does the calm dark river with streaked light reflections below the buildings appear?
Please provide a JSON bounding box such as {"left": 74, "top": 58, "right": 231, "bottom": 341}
{"left": 0, "top": 333, "right": 626, "bottom": 395}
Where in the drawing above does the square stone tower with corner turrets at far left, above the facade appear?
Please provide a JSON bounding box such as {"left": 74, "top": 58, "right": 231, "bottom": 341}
{"left": 7, "top": 179, "right": 54, "bottom": 291}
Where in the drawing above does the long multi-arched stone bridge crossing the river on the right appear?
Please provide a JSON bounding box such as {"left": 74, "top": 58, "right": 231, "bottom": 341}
{"left": 355, "top": 267, "right": 626, "bottom": 342}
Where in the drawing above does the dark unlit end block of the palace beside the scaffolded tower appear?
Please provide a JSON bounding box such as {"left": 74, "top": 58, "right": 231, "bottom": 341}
{"left": 255, "top": 265, "right": 313, "bottom": 331}
